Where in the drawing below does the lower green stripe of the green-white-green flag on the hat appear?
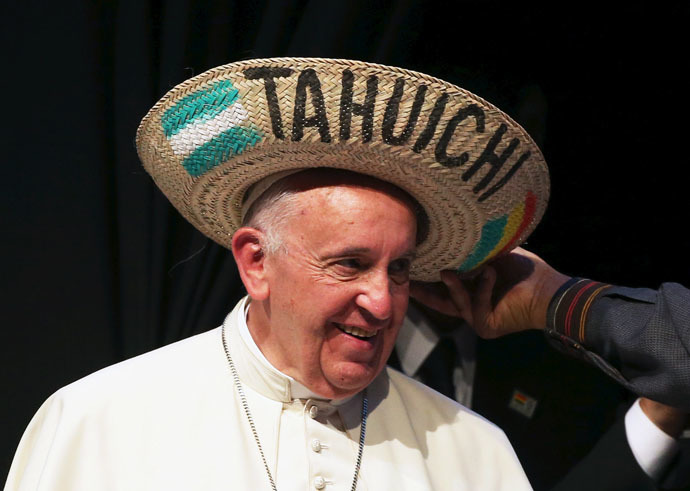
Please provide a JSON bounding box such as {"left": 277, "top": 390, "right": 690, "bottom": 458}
{"left": 182, "top": 126, "right": 263, "bottom": 177}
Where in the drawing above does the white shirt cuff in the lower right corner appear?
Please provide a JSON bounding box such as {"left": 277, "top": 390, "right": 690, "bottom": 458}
{"left": 625, "top": 399, "right": 678, "bottom": 479}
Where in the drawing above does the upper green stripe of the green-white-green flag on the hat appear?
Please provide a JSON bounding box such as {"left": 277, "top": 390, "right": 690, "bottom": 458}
{"left": 161, "top": 80, "right": 239, "bottom": 138}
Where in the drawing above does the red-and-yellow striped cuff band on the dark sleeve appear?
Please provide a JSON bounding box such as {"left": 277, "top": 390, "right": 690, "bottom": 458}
{"left": 546, "top": 278, "right": 611, "bottom": 344}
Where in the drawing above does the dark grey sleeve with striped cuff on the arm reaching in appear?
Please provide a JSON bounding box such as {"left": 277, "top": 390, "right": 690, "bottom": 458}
{"left": 546, "top": 279, "right": 690, "bottom": 410}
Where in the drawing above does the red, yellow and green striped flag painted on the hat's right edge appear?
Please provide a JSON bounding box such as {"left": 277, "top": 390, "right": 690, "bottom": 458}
{"left": 458, "top": 191, "right": 537, "bottom": 271}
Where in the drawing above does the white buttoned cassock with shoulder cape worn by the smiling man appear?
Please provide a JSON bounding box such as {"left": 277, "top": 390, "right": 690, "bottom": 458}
{"left": 5, "top": 299, "right": 531, "bottom": 491}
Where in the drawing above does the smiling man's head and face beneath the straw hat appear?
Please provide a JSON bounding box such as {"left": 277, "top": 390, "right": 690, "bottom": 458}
{"left": 232, "top": 169, "right": 417, "bottom": 399}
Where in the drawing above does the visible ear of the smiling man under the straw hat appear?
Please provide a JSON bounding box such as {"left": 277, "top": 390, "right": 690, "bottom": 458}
{"left": 232, "top": 227, "right": 269, "bottom": 300}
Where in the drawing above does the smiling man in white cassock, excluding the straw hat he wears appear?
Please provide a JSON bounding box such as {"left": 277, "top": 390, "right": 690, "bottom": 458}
{"left": 5, "top": 170, "right": 529, "bottom": 489}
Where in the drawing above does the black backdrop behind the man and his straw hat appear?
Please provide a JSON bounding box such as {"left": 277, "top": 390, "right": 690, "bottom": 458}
{"left": 0, "top": 0, "right": 690, "bottom": 482}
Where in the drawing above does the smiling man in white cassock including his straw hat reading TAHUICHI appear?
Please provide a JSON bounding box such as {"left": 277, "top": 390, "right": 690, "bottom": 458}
{"left": 7, "top": 59, "right": 548, "bottom": 490}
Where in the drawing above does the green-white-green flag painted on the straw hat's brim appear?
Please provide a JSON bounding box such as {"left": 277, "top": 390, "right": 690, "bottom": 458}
{"left": 161, "top": 80, "right": 263, "bottom": 177}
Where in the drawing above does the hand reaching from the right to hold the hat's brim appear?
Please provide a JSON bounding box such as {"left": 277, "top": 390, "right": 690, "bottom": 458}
{"left": 410, "top": 248, "right": 570, "bottom": 339}
